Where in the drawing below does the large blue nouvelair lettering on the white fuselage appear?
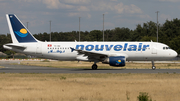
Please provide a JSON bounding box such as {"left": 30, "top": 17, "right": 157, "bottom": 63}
{"left": 76, "top": 43, "right": 150, "bottom": 51}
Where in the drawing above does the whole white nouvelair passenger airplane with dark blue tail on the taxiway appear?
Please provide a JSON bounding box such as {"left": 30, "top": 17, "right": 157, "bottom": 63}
{"left": 3, "top": 14, "right": 177, "bottom": 70}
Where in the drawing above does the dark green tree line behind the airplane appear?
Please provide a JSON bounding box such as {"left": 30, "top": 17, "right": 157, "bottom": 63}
{"left": 0, "top": 18, "right": 180, "bottom": 54}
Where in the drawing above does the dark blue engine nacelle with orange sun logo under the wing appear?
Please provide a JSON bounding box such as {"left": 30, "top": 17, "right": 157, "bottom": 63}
{"left": 102, "top": 56, "right": 126, "bottom": 67}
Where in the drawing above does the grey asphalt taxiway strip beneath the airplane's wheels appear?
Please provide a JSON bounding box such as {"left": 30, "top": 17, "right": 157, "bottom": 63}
{"left": 0, "top": 61, "right": 180, "bottom": 73}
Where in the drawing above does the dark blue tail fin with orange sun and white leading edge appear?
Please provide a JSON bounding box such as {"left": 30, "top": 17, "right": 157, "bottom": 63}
{"left": 6, "top": 14, "right": 38, "bottom": 43}
